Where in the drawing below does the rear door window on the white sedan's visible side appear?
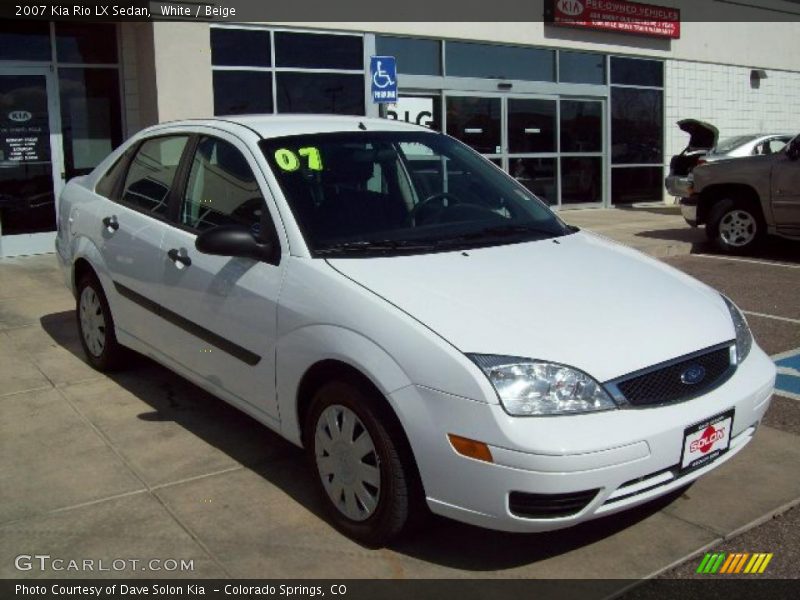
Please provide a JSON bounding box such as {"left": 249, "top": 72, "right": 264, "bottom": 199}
{"left": 121, "top": 135, "right": 189, "bottom": 217}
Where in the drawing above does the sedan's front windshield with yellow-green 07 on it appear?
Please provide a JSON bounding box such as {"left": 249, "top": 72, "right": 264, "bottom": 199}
{"left": 261, "top": 131, "right": 574, "bottom": 256}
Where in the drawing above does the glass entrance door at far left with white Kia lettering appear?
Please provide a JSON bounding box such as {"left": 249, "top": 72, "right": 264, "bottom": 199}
{"left": 0, "top": 67, "right": 63, "bottom": 257}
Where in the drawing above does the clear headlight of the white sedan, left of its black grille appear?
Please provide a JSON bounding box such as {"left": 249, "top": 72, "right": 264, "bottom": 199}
{"left": 467, "top": 354, "right": 617, "bottom": 416}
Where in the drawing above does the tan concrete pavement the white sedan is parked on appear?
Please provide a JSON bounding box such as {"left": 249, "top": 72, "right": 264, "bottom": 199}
{"left": 0, "top": 216, "right": 800, "bottom": 578}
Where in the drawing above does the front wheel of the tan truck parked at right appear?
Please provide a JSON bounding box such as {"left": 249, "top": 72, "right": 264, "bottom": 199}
{"left": 706, "top": 198, "right": 766, "bottom": 254}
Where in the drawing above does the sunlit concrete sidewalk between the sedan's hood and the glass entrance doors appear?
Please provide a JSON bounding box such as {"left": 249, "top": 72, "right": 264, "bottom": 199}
{"left": 559, "top": 205, "right": 706, "bottom": 258}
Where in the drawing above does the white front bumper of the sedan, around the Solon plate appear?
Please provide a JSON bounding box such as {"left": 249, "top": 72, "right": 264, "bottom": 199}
{"left": 391, "top": 347, "right": 775, "bottom": 532}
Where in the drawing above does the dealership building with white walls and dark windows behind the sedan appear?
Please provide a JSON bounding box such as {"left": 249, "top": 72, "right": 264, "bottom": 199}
{"left": 0, "top": 0, "right": 800, "bottom": 256}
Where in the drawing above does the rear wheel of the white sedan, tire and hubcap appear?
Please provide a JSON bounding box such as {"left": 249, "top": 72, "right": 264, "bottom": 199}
{"left": 75, "top": 274, "right": 125, "bottom": 371}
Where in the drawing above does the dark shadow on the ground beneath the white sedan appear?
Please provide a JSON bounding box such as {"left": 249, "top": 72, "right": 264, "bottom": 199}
{"left": 40, "top": 311, "right": 684, "bottom": 572}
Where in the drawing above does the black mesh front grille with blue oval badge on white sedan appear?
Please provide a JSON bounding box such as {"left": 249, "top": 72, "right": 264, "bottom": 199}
{"left": 616, "top": 346, "right": 733, "bottom": 406}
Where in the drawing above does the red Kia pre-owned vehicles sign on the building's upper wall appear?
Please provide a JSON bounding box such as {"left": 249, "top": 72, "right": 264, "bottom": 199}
{"left": 544, "top": 0, "right": 681, "bottom": 39}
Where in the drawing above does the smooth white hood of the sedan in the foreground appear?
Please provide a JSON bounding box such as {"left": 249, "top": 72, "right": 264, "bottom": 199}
{"left": 328, "top": 232, "right": 735, "bottom": 381}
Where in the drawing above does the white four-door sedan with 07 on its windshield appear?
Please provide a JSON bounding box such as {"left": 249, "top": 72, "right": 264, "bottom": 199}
{"left": 56, "top": 116, "right": 775, "bottom": 545}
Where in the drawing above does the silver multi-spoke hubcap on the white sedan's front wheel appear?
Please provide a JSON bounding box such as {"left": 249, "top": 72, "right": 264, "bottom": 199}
{"left": 314, "top": 404, "right": 381, "bottom": 521}
